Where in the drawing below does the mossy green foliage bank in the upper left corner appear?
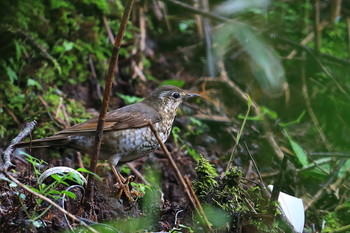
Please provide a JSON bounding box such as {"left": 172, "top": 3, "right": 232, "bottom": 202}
{"left": 0, "top": 0, "right": 133, "bottom": 146}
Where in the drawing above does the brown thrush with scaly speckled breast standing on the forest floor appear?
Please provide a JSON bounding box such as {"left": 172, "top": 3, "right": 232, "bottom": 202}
{"left": 14, "top": 85, "right": 200, "bottom": 200}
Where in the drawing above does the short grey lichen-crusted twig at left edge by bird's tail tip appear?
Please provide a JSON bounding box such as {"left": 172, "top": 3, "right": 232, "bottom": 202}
{"left": 0, "top": 121, "right": 37, "bottom": 172}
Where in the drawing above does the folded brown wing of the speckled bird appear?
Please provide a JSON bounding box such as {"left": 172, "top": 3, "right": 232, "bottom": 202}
{"left": 56, "top": 102, "right": 161, "bottom": 135}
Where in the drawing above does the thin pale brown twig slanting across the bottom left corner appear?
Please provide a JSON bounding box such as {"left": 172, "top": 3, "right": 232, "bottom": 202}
{"left": 3, "top": 170, "right": 98, "bottom": 233}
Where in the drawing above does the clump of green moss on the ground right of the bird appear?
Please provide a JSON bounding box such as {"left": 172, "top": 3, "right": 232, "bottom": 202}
{"left": 194, "top": 161, "right": 283, "bottom": 232}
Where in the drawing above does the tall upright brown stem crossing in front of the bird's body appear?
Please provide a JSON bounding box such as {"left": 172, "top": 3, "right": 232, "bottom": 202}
{"left": 87, "top": 0, "right": 134, "bottom": 201}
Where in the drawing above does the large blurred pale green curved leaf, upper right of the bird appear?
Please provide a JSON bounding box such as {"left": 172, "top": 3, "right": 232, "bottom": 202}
{"left": 213, "top": 21, "right": 286, "bottom": 95}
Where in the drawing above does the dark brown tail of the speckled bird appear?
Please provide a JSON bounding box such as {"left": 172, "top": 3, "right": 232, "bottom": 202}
{"left": 14, "top": 135, "right": 68, "bottom": 148}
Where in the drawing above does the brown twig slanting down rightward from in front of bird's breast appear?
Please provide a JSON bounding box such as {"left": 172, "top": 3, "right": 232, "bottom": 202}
{"left": 148, "top": 121, "right": 212, "bottom": 232}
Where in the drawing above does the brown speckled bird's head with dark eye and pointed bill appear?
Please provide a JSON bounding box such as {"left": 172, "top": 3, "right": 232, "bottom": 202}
{"left": 143, "top": 85, "right": 199, "bottom": 112}
